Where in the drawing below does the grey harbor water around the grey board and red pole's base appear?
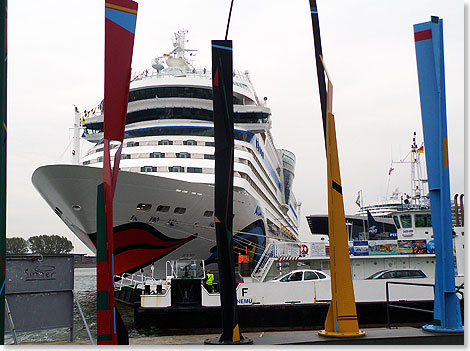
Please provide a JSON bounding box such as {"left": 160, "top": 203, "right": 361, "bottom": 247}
{"left": 5, "top": 268, "right": 158, "bottom": 345}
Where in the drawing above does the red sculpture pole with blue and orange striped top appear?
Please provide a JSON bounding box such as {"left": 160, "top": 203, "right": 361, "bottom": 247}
{"left": 96, "top": 0, "right": 137, "bottom": 345}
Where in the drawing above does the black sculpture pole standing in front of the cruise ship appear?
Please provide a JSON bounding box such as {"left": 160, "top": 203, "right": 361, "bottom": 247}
{"left": 205, "top": 40, "right": 251, "bottom": 344}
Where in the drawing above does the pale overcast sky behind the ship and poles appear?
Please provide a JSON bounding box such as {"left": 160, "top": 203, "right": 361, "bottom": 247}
{"left": 7, "top": 0, "right": 468, "bottom": 254}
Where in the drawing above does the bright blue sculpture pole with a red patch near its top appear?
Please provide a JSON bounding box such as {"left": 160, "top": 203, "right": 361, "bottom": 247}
{"left": 414, "top": 16, "right": 464, "bottom": 332}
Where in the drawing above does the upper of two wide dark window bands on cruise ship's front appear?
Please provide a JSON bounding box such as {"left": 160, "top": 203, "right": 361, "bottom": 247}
{"left": 129, "top": 87, "right": 242, "bottom": 105}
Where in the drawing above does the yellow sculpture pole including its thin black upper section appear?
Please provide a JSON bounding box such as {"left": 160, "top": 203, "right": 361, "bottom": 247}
{"left": 310, "top": 0, "right": 365, "bottom": 337}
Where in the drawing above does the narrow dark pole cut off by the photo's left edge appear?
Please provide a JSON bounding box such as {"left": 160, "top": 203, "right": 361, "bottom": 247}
{"left": 0, "top": 0, "right": 7, "bottom": 345}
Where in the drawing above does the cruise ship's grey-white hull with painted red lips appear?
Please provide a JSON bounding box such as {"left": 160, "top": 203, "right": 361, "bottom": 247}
{"left": 32, "top": 165, "right": 266, "bottom": 276}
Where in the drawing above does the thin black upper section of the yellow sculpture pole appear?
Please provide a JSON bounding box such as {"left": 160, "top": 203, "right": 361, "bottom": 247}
{"left": 309, "top": 0, "right": 326, "bottom": 150}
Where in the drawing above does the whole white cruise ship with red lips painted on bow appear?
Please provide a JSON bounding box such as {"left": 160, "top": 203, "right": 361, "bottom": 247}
{"left": 32, "top": 31, "right": 300, "bottom": 274}
